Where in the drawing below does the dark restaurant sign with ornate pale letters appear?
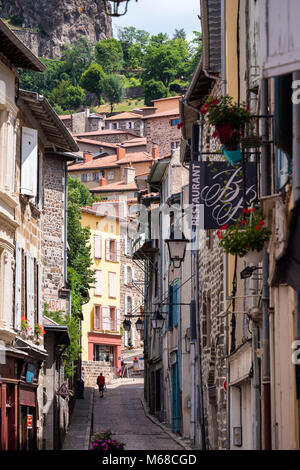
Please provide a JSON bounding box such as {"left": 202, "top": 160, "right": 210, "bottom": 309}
{"left": 190, "top": 161, "right": 257, "bottom": 230}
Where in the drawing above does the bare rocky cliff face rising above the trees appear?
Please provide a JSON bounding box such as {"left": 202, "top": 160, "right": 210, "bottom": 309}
{"left": 1, "top": 0, "right": 112, "bottom": 58}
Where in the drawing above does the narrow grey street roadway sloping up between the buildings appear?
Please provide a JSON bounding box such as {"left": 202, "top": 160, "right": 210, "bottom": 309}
{"left": 93, "top": 378, "right": 182, "bottom": 450}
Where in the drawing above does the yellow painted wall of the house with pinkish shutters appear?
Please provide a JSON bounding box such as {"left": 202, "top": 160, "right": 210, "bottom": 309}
{"left": 81, "top": 212, "right": 120, "bottom": 361}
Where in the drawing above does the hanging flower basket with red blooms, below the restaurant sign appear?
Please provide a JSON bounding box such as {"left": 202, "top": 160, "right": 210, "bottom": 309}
{"left": 217, "top": 208, "right": 271, "bottom": 262}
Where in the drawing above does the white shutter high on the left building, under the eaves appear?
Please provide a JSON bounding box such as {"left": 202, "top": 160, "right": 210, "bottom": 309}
{"left": 21, "top": 127, "right": 38, "bottom": 197}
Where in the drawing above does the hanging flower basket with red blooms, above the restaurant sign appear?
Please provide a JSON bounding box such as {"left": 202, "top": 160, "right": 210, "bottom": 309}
{"left": 201, "top": 95, "right": 251, "bottom": 150}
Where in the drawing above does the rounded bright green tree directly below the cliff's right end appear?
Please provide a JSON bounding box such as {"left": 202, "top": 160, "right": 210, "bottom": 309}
{"left": 95, "top": 38, "right": 123, "bottom": 73}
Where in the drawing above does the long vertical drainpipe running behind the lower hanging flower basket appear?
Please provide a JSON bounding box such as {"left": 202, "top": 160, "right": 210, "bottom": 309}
{"left": 261, "top": 79, "right": 272, "bottom": 450}
